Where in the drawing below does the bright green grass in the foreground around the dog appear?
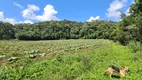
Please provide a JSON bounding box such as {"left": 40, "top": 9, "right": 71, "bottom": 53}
{"left": 0, "top": 40, "right": 142, "bottom": 80}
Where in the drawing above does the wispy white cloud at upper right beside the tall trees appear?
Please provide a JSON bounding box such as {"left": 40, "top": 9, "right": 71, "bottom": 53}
{"left": 106, "top": 0, "right": 128, "bottom": 18}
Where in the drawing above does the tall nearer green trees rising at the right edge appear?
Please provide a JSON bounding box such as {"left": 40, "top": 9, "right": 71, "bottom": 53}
{"left": 117, "top": 0, "right": 142, "bottom": 44}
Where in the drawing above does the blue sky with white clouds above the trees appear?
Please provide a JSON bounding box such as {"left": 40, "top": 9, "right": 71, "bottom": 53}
{"left": 0, "top": 0, "right": 134, "bottom": 24}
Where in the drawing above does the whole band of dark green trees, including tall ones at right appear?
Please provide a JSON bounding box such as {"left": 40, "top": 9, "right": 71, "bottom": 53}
{"left": 0, "top": 0, "right": 142, "bottom": 44}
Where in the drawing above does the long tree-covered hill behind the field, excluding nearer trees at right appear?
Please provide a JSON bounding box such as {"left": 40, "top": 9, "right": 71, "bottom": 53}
{"left": 0, "top": 20, "right": 116, "bottom": 40}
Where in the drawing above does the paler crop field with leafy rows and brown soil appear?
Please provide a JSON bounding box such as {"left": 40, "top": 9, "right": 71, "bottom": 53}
{"left": 0, "top": 40, "right": 105, "bottom": 64}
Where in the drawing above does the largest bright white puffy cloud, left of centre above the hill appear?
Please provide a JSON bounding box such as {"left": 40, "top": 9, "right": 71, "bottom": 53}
{"left": 22, "top": 4, "right": 59, "bottom": 21}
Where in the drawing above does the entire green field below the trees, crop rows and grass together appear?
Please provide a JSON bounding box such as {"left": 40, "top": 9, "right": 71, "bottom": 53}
{"left": 0, "top": 39, "right": 142, "bottom": 80}
